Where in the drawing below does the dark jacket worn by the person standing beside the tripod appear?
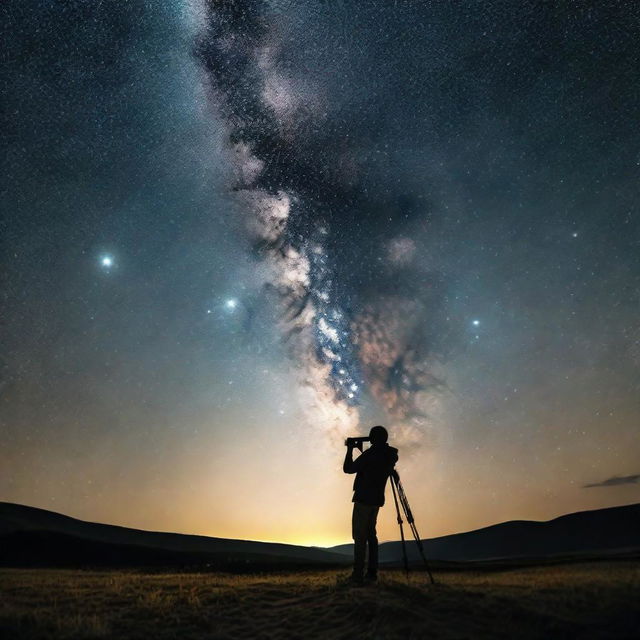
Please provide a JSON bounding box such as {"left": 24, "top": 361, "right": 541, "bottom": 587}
{"left": 343, "top": 442, "right": 398, "bottom": 507}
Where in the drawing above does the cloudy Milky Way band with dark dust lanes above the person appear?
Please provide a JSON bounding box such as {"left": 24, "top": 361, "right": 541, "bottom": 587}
{"left": 192, "top": 1, "right": 446, "bottom": 438}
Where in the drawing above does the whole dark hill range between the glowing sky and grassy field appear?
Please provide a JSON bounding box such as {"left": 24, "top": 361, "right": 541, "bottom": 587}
{"left": 0, "top": 502, "right": 640, "bottom": 570}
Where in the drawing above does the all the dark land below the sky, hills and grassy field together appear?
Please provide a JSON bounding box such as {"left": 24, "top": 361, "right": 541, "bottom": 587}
{"left": 0, "top": 503, "right": 640, "bottom": 640}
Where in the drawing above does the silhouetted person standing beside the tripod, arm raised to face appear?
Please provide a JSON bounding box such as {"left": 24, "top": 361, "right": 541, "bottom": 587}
{"left": 342, "top": 426, "right": 398, "bottom": 584}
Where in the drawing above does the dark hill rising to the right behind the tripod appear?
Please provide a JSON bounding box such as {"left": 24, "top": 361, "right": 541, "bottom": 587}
{"left": 331, "top": 504, "right": 640, "bottom": 562}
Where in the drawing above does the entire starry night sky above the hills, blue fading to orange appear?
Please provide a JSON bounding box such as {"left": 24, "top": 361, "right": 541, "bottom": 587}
{"left": 0, "top": 0, "right": 640, "bottom": 545}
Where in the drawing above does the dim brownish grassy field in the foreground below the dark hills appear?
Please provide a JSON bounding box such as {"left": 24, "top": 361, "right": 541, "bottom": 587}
{"left": 0, "top": 562, "right": 640, "bottom": 640}
